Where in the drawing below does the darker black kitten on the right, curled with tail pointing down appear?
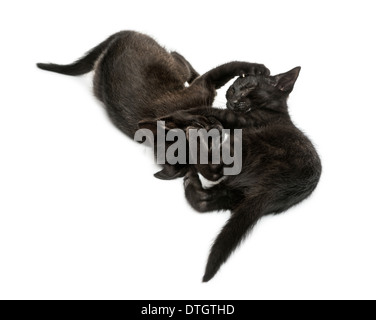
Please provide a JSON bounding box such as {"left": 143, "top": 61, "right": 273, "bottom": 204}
{"left": 157, "top": 67, "right": 321, "bottom": 282}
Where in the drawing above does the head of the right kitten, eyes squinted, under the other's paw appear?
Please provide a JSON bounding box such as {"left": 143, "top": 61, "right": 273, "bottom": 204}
{"left": 226, "top": 67, "right": 300, "bottom": 113}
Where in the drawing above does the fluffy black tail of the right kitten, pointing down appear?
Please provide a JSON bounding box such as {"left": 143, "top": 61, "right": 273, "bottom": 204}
{"left": 203, "top": 199, "right": 262, "bottom": 282}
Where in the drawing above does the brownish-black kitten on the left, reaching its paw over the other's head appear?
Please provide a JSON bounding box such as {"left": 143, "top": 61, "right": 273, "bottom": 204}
{"left": 38, "top": 31, "right": 269, "bottom": 179}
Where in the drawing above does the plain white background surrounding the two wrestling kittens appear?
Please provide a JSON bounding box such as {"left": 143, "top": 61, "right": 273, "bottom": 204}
{"left": 0, "top": 0, "right": 376, "bottom": 299}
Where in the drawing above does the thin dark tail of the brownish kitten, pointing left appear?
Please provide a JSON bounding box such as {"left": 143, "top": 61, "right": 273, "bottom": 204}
{"left": 37, "top": 34, "right": 117, "bottom": 76}
